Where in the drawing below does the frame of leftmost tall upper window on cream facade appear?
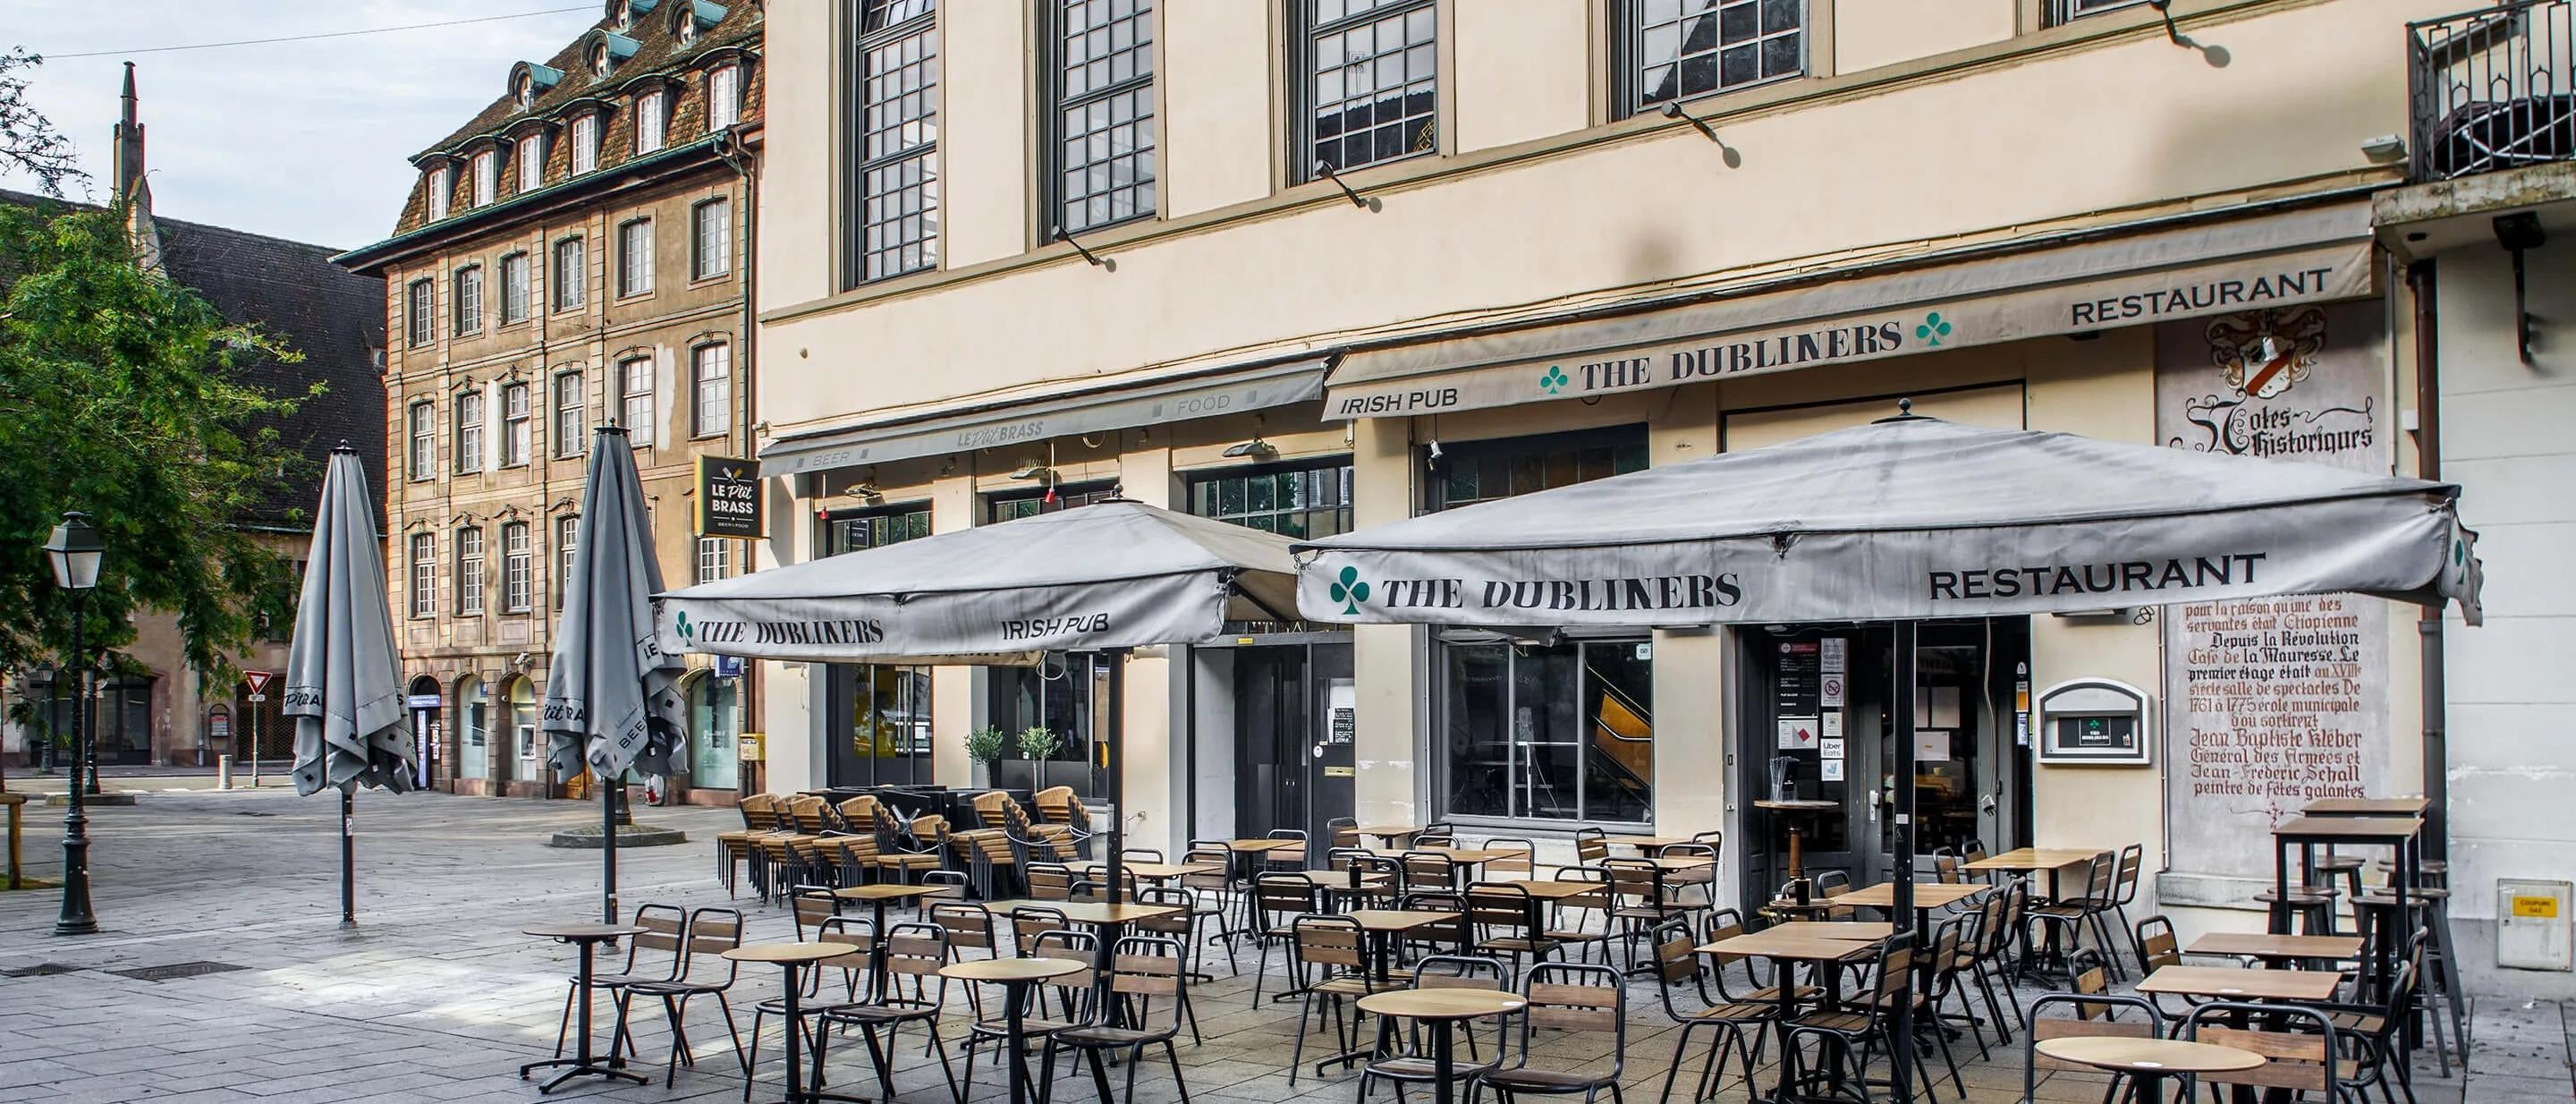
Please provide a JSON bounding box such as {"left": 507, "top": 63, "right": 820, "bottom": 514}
{"left": 843, "top": 0, "right": 945, "bottom": 286}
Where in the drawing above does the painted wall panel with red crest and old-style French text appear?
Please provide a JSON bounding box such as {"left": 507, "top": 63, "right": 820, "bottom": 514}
{"left": 2157, "top": 301, "right": 2394, "bottom": 882}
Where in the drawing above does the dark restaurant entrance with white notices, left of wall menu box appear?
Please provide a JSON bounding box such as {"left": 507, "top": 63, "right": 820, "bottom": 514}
{"left": 1736, "top": 619, "right": 2029, "bottom": 908}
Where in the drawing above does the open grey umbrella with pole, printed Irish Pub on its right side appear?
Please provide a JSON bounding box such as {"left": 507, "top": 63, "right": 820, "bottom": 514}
{"left": 659, "top": 497, "right": 1296, "bottom": 887}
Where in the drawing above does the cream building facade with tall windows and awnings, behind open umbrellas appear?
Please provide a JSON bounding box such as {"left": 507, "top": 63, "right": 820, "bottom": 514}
{"left": 755, "top": 0, "right": 2555, "bottom": 995}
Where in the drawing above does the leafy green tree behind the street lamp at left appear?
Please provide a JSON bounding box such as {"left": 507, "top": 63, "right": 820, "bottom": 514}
{"left": 0, "top": 201, "right": 304, "bottom": 722}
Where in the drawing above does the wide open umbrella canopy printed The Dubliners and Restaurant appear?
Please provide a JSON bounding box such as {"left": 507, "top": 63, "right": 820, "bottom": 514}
{"left": 1299, "top": 415, "right": 2479, "bottom": 627}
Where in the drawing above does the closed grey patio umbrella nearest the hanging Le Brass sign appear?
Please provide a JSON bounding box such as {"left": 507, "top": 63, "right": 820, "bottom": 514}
{"left": 544, "top": 426, "right": 688, "bottom": 923}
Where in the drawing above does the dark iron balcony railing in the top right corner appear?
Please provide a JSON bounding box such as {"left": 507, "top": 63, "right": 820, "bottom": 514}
{"left": 2406, "top": 0, "right": 2576, "bottom": 181}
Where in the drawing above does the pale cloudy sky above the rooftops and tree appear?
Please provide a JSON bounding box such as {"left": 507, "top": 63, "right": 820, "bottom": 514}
{"left": 0, "top": 0, "right": 603, "bottom": 248}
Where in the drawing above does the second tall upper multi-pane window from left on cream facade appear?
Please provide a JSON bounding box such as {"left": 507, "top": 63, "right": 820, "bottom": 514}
{"left": 1054, "top": 0, "right": 1154, "bottom": 230}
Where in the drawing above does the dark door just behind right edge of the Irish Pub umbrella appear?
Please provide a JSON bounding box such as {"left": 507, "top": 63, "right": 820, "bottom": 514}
{"left": 1234, "top": 642, "right": 1358, "bottom": 841}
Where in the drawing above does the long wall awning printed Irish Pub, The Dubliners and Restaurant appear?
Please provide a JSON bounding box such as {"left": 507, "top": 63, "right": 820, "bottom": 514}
{"left": 1324, "top": 204, "right": 2375, "bottom": 418}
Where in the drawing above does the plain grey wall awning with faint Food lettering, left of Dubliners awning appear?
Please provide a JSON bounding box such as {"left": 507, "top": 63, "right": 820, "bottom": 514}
{"left": 760, "top": 356, "right": 1332, "bottom": 477}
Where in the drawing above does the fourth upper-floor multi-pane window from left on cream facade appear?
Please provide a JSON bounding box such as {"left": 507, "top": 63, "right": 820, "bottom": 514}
{"left": 1625, "top": 0, "right": 1806, "bottom": 108}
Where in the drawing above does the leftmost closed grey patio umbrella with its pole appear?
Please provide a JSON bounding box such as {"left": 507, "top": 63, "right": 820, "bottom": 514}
{"left": 284, "top": 441, "right": 418, "bottom": 926}
